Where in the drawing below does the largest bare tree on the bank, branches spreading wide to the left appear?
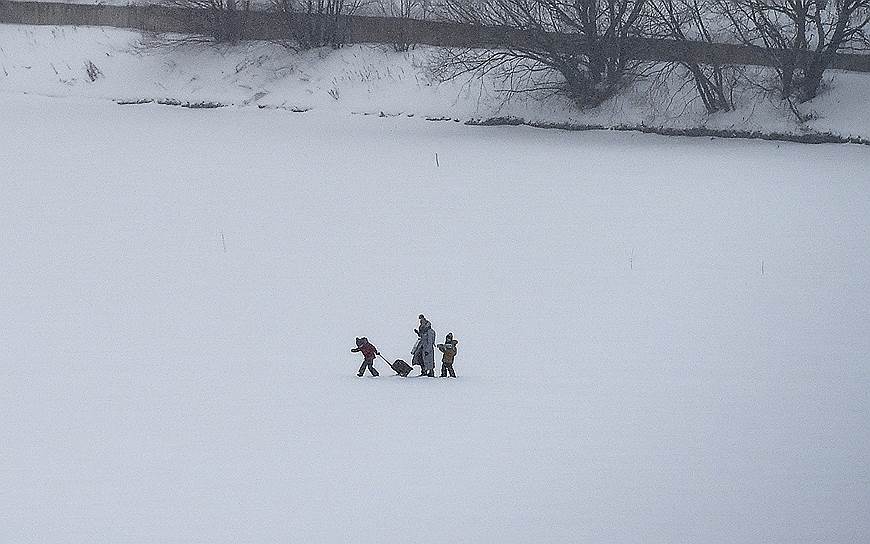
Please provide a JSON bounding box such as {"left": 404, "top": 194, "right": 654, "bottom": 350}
{"left": 440, "top": 0, "right": 648, "bottom": 107}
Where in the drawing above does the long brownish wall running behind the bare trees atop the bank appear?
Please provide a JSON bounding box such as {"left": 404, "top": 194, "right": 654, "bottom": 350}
{"left": 0, "top": 0, "right": 870, "bottom": 72}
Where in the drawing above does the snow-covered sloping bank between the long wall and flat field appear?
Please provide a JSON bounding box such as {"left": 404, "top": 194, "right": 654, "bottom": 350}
{"left": 0, "top": 25, "right": 870, "bottom": 138}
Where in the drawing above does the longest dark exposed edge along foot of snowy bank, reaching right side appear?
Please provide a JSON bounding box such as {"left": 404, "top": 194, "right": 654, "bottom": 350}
{"left": 465, "top": 117, "right": 870, "bottom": 146}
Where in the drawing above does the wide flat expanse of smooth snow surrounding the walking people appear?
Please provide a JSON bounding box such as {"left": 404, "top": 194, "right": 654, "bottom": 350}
{"left": 0, "top": 94, "right": 870, "bottom": 544}
